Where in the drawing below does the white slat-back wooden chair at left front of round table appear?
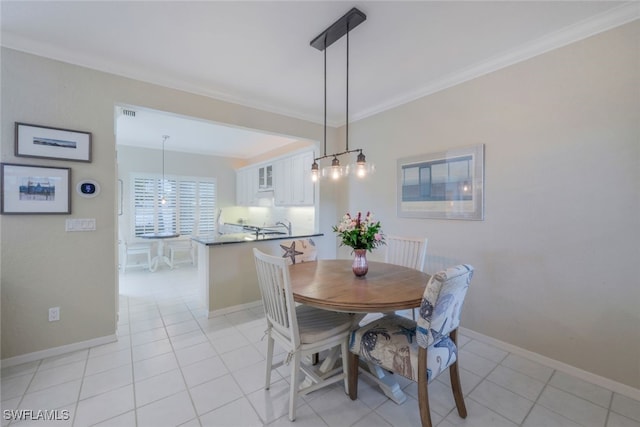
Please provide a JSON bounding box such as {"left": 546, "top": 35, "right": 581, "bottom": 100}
{"left": 253, "top": 248, "right": 352, "bottom": 421}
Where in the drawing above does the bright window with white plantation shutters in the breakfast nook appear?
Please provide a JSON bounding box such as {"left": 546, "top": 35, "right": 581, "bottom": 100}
{"left": 131, "top": 174, "right": 216, "bottom": 241}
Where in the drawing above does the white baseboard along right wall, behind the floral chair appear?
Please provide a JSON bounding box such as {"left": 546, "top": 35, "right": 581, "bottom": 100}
{"left": 460, "top": 327, "right": 640, "bottom": 400}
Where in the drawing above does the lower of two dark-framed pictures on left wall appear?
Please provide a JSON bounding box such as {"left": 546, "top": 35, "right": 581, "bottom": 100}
{"left": 0, "top": 163, "right": 71, "bottom": 214}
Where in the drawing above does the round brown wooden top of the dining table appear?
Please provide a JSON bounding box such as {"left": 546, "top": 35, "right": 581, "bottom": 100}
{"left": 289, "top": 259, "right": 431, "bottom": 313}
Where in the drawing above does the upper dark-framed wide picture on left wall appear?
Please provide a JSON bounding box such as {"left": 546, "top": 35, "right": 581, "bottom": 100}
{"left": 15, "top": 122, "right": 91, "bottom": 162}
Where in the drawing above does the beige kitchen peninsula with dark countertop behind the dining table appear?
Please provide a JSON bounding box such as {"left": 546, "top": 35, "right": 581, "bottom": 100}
{"left": 192, "top": 233, "right": 324, "bottom": 317}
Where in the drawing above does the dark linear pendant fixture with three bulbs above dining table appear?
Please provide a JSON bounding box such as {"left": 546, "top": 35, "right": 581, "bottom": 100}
{"left": 311, "top": 7, "right": 374, "bottom": 182}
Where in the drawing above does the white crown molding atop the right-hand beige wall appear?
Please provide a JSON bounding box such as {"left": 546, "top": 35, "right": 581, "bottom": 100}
{"left": 350, "top": 1, "right": 640, "bottom": 125}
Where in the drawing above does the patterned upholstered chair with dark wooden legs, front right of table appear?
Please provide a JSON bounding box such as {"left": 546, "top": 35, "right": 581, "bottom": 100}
{"left": 348, "top": 265, "right": 473, "bottom": 427}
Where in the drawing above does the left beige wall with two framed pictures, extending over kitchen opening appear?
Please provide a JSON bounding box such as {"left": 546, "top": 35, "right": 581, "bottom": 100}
{"left": 0, "top": 48, "right": 335, "bottom": 359}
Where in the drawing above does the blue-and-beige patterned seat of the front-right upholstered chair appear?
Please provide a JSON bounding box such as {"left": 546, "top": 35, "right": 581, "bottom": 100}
{"left": 349, "top": 314, "right": 457, "bottom": 381}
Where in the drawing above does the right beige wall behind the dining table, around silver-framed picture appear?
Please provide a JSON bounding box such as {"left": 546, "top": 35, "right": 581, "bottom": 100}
{"left": 341, "top": 21, "right": 640, "bottom": 388}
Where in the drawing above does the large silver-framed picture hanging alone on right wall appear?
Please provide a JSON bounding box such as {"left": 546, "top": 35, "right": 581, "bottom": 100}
{"left": 397, "top": 144, "right": 484, "bottom": 221}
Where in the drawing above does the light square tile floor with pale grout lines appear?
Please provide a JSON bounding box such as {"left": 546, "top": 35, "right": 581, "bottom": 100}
{"left": 1, "top": 267, "right": 640, "bottom": 427}
